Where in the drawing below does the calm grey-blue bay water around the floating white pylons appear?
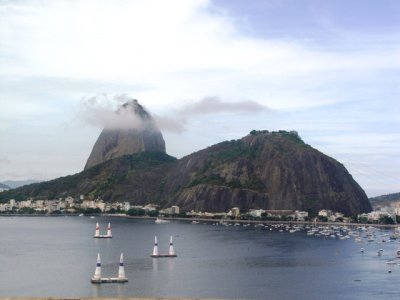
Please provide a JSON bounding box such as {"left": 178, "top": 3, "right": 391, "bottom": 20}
{"left": 0, "top": 217, "right": 400, "bottom": 300}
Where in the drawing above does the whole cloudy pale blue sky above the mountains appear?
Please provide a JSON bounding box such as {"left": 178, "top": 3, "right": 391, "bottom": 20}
{"left": 0, "top": 0, "right": 400, "bottom": 197}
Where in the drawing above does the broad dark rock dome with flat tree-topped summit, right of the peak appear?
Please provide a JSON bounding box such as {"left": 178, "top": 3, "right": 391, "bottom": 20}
{"left": 163, "top": 131, "right": 371, "bottom": 215}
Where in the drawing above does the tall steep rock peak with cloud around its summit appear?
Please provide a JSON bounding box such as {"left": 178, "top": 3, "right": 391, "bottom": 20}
{"left": 85, "top": 100, "right": 165, "bottom": 170}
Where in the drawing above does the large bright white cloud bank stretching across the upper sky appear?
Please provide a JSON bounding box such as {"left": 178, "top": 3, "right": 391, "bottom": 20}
{"left": 0, "top": 0, "right": 400, "bottom": 109}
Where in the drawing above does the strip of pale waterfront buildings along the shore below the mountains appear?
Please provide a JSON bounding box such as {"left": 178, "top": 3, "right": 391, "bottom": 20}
{"left": 0, "top": 195, "right": 400, "bottom": 223}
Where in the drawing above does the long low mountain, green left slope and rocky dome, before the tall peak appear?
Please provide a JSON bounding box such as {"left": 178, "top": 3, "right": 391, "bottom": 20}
{"left": 0, "top": 131, "right": 371, "bottom": 215}
